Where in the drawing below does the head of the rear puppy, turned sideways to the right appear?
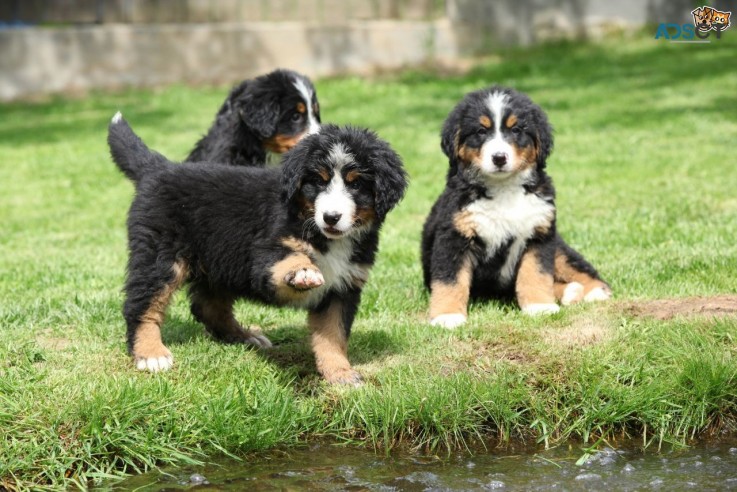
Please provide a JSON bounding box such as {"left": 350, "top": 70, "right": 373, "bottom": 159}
{"left": 226, "top": 70, "right": 320, "bottom": 154}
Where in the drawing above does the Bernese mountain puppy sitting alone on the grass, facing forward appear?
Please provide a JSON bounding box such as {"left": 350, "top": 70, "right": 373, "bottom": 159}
{"left": 422, "top": 86, "right": 611, "bottom": 328}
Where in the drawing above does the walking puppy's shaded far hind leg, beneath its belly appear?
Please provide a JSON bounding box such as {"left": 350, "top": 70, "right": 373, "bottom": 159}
{"left": 190, "top": 285, "right": 272, "bottom": 348}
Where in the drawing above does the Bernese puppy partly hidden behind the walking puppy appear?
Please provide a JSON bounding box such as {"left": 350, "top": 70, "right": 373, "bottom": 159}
{"left": 185, "top": 69, "right": 320, "bottom": 166}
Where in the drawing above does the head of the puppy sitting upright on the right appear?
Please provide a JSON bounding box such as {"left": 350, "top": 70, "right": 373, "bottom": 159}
{"left": 441, "top": 86, "right": 553, "bottom": 180}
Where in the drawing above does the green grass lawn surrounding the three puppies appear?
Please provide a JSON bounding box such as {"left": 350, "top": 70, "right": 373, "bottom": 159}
{"left": 0, "top": 36, "right": 737, "bottom": 488}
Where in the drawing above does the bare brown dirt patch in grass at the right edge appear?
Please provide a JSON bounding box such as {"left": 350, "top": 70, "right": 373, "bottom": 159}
{"left": 625, "top": 294, "right": 737, "bottom": 320}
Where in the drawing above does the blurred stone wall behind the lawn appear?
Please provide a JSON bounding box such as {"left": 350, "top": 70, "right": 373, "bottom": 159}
{"left": 0, "top": 0, "right": 729, "bottom": 101}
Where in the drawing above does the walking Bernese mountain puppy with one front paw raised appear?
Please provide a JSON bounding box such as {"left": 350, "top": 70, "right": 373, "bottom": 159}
{"left": 108, "top": 113, "right": 407, "bottom": 384}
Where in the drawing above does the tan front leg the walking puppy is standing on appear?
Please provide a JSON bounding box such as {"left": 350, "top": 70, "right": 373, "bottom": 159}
{"left": 308, "top": 301, "right": 361, "bottom": 385}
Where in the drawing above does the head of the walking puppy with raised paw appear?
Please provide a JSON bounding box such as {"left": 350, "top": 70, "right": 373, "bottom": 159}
{"left": 282, "top": 125, "right": 407, "bottom": 239}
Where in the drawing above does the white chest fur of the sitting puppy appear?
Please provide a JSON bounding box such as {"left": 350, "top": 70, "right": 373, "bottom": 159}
{"left": 464, "top": 186, "right": 555, "bottom": 284}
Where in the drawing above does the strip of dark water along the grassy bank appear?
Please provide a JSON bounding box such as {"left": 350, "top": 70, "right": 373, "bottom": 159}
{"left": 112, "top": 441, "right": 737, "bottom": 491}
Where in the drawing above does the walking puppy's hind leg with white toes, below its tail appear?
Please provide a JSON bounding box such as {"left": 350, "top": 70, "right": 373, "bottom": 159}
{"left": 124, "top": 261, "right": 188, "bottom": 372}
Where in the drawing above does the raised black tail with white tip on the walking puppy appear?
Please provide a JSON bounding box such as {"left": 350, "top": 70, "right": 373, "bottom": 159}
{"left": 107, "top": 111, "right": 169, "bottom": 183}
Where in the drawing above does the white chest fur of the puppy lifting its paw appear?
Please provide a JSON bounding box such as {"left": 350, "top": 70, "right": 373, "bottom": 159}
{"left": 300, "top": 238, "right": 368, "bottom": 307}
